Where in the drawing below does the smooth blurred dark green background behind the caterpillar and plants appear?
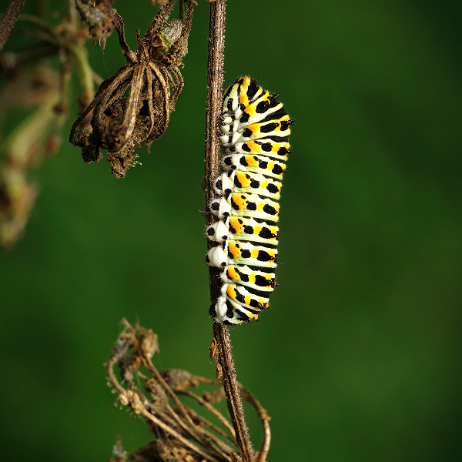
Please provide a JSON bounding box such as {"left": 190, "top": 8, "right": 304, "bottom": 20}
{"left": 0, "top": 0, "right": 462, "bottom": 462}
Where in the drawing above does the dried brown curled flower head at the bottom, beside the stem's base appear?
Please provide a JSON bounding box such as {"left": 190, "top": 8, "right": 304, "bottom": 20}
{"left": 107, "top": 320, "right": 270, "bottom": 462}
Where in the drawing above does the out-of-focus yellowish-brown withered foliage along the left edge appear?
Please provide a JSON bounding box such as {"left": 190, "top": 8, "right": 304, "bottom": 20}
{"left": 0, "top": 2, "right": 94, "bottom": 247}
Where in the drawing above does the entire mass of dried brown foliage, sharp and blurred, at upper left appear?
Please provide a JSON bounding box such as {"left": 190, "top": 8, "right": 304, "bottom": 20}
{"left": 0, "top": 0, "right": 195, "bottom": 246}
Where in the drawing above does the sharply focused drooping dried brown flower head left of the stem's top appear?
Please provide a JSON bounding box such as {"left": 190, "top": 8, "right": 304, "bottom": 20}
{"left": 70, "top": 0, "right": 196, "bottom": 178}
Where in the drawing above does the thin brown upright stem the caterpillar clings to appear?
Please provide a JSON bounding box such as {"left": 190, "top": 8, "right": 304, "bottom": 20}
{"left": 204, "top": 0, "right": 253, "bottom": 462}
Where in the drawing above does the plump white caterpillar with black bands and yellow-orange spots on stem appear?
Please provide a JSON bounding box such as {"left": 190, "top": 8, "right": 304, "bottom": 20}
{"left": 206, "top": 77, "right": 293, "bottom": 325}
